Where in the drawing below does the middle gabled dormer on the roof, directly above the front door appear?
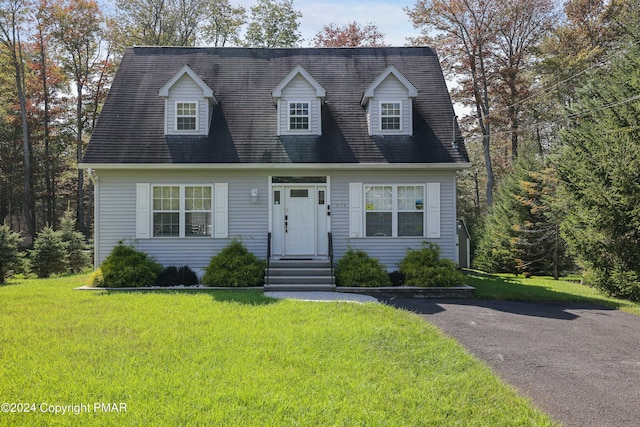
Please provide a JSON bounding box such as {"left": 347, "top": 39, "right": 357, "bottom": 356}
{"left": 271, "top": 65, "right": 326, "bottom": 135}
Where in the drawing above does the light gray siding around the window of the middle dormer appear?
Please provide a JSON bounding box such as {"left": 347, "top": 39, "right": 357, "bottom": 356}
{"left": 278, "top": 74, "right": 322, "bottom": 135}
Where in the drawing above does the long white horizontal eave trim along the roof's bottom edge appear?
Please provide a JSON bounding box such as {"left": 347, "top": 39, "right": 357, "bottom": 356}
{"left": 78, "top": 162, "right": 472, "bottom": 174}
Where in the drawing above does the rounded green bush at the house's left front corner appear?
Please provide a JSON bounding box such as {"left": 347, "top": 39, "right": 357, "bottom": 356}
{"left": 100, "top": 243, "right": 162, "bottom": 288}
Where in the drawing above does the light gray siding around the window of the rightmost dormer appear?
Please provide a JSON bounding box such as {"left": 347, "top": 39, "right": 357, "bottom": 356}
{"left": 367, "top": 75, "right": 413, "bottom": 135}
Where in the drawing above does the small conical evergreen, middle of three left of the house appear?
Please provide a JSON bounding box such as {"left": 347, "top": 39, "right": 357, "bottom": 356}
{"left": 30, "top": 227, "right": 69, "bottom": 278}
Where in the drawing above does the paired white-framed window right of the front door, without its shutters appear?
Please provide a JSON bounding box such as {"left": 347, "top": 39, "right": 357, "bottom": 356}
{"left": 364, "top": 185, "right": 425, "bottom": 237}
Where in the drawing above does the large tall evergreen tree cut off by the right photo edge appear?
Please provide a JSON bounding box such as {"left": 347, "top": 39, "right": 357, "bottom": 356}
{"left": 557, "top": 39, "right": 640, "bottom": 300}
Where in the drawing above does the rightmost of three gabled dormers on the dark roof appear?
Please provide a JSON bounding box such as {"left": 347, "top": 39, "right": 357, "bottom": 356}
{"left": 361, "top": 65, "right": 418, "bottom": 135}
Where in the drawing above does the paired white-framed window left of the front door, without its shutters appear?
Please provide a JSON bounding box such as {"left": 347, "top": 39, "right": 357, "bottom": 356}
{"left": 152, "top": 185, "right": 213, "bottom": 237}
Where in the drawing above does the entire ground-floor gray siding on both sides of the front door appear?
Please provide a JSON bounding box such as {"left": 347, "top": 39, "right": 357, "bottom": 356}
{"left": 96, "top": 170, "right": 456, "bottom": 274}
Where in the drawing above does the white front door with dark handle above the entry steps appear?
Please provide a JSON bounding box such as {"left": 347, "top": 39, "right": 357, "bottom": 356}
{"left": 284, "top": 186, "right": 316, "bottom": 255}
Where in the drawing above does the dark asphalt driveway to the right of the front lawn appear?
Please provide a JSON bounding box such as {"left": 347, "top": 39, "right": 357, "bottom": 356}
{"left": 384, "top": 298, "right": 640, "bottom": 427}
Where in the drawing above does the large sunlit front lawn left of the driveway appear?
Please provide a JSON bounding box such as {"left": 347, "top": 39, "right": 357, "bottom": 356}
{"left": 0, "top": 276, "right": 552, "bottom": 426}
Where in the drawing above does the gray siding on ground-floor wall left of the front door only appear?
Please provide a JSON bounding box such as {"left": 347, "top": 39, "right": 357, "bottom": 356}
{"left": 96, "top": 171, "right": 268, "bottom": 273}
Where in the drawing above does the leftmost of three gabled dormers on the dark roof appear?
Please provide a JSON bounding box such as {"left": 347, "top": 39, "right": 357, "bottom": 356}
{"left": 159, "top": 65, "right": 218, "bottom": 135}
